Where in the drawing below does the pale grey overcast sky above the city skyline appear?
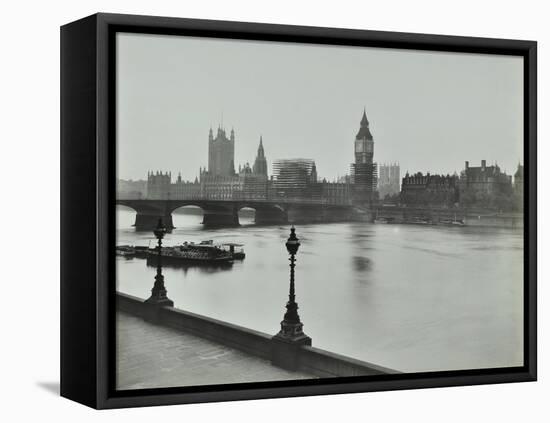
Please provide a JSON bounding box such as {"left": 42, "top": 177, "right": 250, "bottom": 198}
{"left": 117, "top": 34, "right": 523, "bottom": 180}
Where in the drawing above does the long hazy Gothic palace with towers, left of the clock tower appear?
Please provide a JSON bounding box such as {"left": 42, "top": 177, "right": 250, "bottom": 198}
{"left": 118, "top": 122, "right": 356, "bottom": 204}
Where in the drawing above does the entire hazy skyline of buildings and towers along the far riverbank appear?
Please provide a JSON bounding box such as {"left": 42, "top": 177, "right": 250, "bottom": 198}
{"left": 117, "top": 111, "right": 523, "bottom": 212}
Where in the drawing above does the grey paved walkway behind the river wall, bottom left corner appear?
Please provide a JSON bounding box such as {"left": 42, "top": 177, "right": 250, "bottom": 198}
{"left": 116, "top": 311, "right": 315, "bottom": 389}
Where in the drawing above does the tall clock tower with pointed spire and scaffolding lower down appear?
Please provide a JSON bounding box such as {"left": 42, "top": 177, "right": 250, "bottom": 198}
{"left": 352, "top": 110, "right": 376, "bottom": 203}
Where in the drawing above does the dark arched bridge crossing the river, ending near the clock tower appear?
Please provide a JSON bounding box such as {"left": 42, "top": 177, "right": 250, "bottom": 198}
{"left": 116, "top": 198, "right": 356, "bottom": 230}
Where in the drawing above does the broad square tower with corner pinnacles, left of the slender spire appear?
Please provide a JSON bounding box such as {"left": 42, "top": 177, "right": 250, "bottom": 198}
{"left": 208, "top": 126, "right": 235, "bottom": 177}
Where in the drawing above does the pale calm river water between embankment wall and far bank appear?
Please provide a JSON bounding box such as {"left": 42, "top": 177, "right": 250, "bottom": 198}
{"left": 116, "top": 207, "right": 523, "bottom": 372}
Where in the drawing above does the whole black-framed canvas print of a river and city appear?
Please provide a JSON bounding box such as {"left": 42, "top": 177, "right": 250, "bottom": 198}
{"left": 61, "top": 14, "right": 536, "bottom": 408}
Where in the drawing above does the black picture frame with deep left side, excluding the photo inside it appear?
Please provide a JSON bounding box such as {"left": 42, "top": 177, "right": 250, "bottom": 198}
{"left": 60, "top": 13, "right": 537, "bottom": 409}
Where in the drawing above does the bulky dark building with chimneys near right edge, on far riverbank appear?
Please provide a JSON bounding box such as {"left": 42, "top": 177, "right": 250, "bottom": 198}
{"left": 459, "top": 160, "right": 512, "bottom": 209}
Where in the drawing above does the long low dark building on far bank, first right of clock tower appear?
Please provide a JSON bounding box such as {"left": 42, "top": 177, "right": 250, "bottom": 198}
{"left": 400, "top": 172, "right": 458, "bottom": 207}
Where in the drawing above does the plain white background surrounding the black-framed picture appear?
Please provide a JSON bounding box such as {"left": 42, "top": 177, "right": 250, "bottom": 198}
{"left": 0, "top": 0, "right": 550, "bottom": 422}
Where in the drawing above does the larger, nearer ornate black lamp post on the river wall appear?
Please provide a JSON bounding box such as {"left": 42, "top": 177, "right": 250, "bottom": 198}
{"left": 273, "top": 226, "right": 311, "bottom": 345}
